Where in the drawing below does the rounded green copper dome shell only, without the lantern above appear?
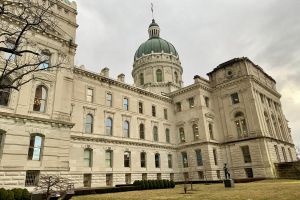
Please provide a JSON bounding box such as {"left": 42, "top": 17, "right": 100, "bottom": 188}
{"left": 134, "top": 37, "right": 178, "bottom": 59}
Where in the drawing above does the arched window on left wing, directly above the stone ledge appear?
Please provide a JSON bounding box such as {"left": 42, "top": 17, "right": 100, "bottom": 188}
{"left": 33, "top": 85, "right": 47, "bottom": 112}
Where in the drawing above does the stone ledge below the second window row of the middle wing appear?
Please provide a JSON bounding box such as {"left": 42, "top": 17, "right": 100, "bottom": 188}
{"left": 71, "top": 135, "right": 175, "bottom": 150}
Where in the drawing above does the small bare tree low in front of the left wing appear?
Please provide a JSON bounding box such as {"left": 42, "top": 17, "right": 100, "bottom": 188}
{"left": 35, "top": 175, "right": 74, "bottom": 199}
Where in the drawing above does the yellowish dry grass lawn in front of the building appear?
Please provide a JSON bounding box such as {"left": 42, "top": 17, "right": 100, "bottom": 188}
{"left": 72, "top": 180, "right": 300, "bottom": 200}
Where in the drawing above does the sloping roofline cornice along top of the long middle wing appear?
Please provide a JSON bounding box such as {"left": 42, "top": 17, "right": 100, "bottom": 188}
{"left": 73, "top": 67, "right": 172, "bottom": 103}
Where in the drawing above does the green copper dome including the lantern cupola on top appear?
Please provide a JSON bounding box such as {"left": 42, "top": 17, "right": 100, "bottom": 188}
{"left": 134, "top": 19, "right": 178, "bottom": 60}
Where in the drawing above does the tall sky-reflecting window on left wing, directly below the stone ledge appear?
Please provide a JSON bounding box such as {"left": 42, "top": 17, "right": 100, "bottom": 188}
{"left": 28, "top": 134, "right": 43, "bottom": 160}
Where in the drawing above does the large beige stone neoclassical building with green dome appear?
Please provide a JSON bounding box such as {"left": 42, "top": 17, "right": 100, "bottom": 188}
{"left": 0, "top": 1, "right": 296, "bottom": 188}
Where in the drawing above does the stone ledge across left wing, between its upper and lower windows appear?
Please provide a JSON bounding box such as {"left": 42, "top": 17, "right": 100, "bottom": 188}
{"left": 0, "top": 112, "right": 75, "bottom": 128}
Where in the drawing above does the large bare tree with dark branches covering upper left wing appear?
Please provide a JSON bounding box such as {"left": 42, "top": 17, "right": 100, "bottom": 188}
{"left": 0, "top": 0, "right": 68, "bottom": 90}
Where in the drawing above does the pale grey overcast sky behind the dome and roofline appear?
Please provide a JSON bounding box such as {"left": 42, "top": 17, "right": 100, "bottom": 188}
{"left": 75, "top": 0, "right": 300, "bottom": 146}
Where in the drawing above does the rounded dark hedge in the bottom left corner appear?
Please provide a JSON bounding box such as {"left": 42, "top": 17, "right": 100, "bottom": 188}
{"left": 0, "top": 188, "right": 31, "bottom": 200}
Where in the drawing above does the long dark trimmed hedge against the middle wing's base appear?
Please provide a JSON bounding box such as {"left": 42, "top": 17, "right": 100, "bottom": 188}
{"left": 133, "top": 180, "right": 175, "bottom": 190}
